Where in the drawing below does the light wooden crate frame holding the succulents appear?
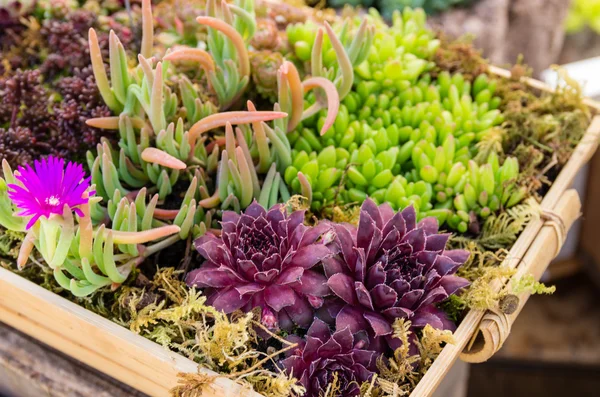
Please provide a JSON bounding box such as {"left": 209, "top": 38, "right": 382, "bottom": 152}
{"left": 0, "top": 68, "right": 600, "bottom": 397}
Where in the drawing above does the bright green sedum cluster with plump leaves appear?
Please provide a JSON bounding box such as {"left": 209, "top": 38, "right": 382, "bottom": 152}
{"left": 284, "top": 9, "right": 524, "bottom": 232}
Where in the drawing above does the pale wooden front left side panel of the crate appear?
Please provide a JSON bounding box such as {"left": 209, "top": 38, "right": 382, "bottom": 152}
{"left": 0, "top": 268, "right": 258, "bottom": 397}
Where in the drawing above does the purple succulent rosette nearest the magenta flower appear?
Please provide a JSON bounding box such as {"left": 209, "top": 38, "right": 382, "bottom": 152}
{"left": 186, "top": 202, "right": 331, "bottom": 331}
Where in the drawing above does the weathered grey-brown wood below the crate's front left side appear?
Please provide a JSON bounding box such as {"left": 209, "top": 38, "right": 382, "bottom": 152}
{"left": 0, "top": 323, "right": 145, "bottom": 397}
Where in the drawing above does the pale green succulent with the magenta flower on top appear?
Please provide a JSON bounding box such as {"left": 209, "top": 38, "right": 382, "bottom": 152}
{"left": 0, "top": 156, "right": 183, "bottom": 296}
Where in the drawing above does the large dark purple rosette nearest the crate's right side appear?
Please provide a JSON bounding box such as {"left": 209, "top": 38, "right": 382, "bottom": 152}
{"left": 320, "top": 199, "right": 469, "bottom": 351}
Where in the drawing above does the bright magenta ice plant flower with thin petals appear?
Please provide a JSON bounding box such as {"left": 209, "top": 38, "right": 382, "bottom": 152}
{"left": 8, "top": 156, "right": 90, "bottom": 229}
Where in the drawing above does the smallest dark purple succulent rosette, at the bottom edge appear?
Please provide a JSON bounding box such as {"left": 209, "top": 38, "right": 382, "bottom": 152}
{"left": 282, "top": 318, "right": 379, "bottom": 397}
